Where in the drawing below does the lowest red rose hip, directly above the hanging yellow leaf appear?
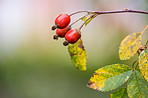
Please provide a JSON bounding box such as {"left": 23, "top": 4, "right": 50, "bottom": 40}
{"left": 65, "top": 29, "right": 81, "bottom": 44}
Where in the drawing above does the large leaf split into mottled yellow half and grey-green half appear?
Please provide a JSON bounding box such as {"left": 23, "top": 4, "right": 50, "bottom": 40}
{"left": 87, "top": 64, "right": 132, "bottom": 92}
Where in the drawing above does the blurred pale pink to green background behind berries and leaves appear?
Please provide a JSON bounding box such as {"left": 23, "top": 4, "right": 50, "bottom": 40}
{"left": 0, "top": 0, "right": 148, "bottom": 98}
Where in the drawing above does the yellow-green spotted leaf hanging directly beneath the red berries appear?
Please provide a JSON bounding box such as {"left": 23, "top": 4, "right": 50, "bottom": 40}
{"left": 68, "top": 39, "right": 87, "bottom": 71}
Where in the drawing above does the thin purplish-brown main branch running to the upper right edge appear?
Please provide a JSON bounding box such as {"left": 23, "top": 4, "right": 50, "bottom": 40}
{"left": 93, "top": 9, "right": 148, "bottom": 15}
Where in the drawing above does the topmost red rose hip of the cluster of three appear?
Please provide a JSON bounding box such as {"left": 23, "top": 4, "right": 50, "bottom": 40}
{"left": 55, "top": 14, "right": 70, "bottom": 29}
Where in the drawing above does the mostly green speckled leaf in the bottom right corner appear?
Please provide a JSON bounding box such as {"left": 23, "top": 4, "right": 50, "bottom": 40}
{"left": 127, "top": 71, "right": 148, "bottom": 98}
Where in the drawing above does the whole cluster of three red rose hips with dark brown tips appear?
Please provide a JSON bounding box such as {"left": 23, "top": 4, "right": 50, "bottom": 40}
{"left": 52, "top": 14, "right": 81, "bottom": 46}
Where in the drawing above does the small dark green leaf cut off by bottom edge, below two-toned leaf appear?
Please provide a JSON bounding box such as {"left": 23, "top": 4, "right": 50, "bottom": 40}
{"left": 110, "top": 88, "right": 128, "bottom": 98}
